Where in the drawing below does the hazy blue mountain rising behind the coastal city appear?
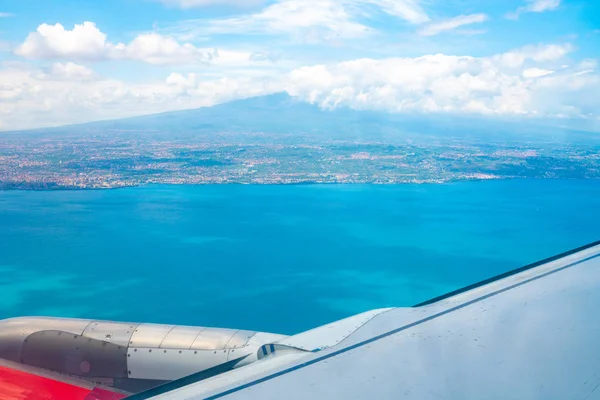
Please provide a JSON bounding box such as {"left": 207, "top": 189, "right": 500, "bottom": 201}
{"left": 10, "top": 92, "right": 598, "bottom": 142}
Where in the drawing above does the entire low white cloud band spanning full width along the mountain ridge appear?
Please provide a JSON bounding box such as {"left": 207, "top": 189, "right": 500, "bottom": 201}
{"left": 0, "top": 45, "right": 600, "bottom": 129}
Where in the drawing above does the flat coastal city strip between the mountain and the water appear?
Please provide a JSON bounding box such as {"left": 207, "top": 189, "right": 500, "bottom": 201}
{"left": 0, "top": 133, "right": 600, "bottom": 190}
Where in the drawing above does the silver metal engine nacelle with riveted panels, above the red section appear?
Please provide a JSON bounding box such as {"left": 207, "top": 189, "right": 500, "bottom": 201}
{"left": 0, "top": 317, "right": 286, "bottom": 391}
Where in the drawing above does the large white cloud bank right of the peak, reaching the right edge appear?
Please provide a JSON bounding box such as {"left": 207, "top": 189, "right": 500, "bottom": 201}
{"left": 286, "top": 50, "right": 600, "bottom": 117}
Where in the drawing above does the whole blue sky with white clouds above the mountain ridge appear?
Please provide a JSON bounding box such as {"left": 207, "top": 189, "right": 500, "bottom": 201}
{"left": 0, "top": 0, "right": 600, "bottom": 130}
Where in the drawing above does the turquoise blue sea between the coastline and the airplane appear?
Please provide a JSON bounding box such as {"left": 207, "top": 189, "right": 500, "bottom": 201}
{"left": 0, "top": 180, "right": 600, "bottom": 333}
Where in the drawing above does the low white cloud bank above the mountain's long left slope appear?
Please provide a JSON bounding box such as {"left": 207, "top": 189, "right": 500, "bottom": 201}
{"left": 0, "top": 64, "right": 281, "bottom": 130}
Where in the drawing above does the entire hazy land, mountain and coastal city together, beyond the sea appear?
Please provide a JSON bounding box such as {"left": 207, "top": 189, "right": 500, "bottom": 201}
{"left": 0, "top": 95, "right": 600, "bottom": 189}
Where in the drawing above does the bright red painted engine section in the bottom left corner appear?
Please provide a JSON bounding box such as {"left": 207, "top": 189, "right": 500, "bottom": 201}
{"left": 0, "top": 360, "right": 126, "bottom": 400}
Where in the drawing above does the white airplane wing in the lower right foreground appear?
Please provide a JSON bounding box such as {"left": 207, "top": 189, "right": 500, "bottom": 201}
{"left": 128, "top": 242, "right": 600, "bottom": 400}
